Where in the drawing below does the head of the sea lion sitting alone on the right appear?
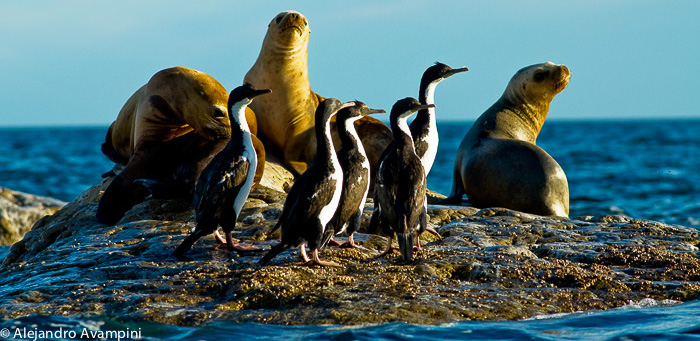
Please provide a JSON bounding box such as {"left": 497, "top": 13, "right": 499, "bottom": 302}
{"left": 504, "top": 62, "right": 571, "bottom": 106}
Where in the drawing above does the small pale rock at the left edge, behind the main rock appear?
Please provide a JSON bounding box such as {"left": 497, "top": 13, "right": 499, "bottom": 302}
{"left": 0, "top": 187, "right": 66, "bottom": 245}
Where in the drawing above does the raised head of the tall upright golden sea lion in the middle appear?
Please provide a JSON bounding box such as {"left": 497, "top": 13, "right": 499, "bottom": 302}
{"left": 265, "top": 11, "right": 311, "bottom": 50}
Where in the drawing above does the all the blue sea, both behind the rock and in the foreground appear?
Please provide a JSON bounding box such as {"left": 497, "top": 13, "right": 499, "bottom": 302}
{"left": 0, "top": 120, "right": 700, "bottom": 340}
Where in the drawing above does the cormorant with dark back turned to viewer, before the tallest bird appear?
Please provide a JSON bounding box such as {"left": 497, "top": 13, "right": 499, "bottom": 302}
{"left": 372, "top": 97, "right": 434, "bottom": 262}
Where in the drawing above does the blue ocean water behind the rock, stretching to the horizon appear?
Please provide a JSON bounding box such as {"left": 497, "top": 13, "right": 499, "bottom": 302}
{"left": 0, "top": 120, "right": 700, "bottom": 226}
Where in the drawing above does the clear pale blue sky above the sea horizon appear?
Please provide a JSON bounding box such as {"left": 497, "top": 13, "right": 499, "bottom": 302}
{"left": 0, "top": 0, "right": 700, "bottom": 127}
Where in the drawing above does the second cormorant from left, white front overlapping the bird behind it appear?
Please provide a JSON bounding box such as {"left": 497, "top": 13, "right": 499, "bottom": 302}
{"left": 260, "top": 98, "right": 355, "bottom": 266}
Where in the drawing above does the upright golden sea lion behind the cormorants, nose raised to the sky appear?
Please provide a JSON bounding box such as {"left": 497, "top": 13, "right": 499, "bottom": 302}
{"left": 244, "top": 11, "right": 392, "bottom": 178}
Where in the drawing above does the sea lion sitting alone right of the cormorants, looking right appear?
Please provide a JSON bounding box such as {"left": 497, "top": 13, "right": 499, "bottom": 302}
{"left": 443, "top": 62, "right": 571, "bottom": 217}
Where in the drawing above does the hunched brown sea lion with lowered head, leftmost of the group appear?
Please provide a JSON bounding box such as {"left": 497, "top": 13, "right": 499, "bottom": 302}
{"left": 97, "top": 66, "right": 265, "bottom": 225}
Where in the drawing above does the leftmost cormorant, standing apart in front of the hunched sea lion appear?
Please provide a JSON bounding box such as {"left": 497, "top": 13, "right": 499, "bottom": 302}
{"left": 174, "top": 83, "right": 271, "bottom": 257}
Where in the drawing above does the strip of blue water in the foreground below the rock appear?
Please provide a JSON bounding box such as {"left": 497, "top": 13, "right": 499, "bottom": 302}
{"left": 0, "top": 302, "right": 700, "bottom": 341}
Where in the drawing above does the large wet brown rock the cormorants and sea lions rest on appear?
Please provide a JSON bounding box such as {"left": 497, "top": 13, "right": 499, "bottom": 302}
{"left": 0, "top": 169, "right": 700, "bottom": 325}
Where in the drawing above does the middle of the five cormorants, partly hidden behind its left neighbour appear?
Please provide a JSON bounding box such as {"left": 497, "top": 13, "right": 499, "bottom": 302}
{"left": 331, "top": 101, "right": 386, "bottom": 247}
